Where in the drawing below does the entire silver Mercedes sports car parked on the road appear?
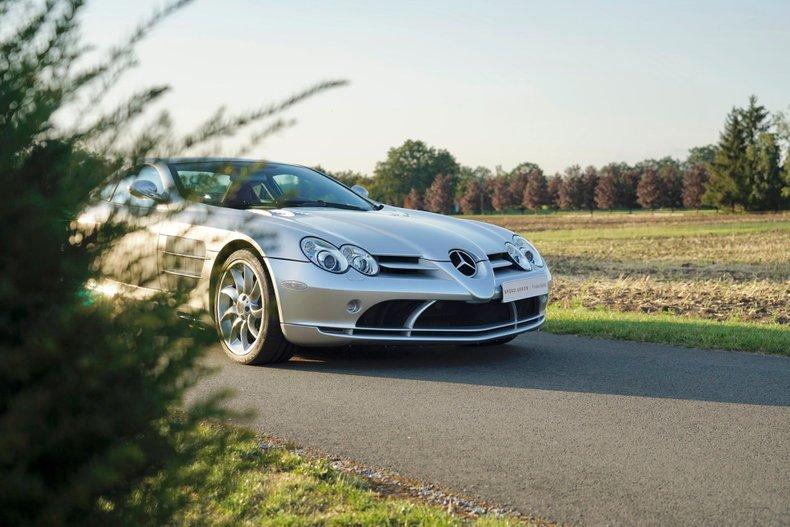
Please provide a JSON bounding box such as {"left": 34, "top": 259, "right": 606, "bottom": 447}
{"left": 78, "top": 158, "right": 551, "bottom": 363}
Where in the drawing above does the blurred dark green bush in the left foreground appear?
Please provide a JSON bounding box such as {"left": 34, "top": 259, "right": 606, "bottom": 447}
{"left": 0, "top": 0, "right": 339, "bottom": 525}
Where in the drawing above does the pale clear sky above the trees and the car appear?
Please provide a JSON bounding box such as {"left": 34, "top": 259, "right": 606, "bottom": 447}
{"left": 77, "top": 0, "right": 790, "bottom": 172}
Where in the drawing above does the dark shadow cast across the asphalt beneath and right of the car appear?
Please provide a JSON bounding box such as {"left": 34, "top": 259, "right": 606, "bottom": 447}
{"left": 270, "top": 333, "right": 790, "bottom": 406}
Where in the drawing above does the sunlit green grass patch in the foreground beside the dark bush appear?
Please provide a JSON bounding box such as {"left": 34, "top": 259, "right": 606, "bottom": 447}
{"left": 119, "top": 423, "right": 523, "bottom": 526}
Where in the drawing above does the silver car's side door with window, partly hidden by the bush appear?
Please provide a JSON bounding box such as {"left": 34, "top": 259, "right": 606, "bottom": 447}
{"left": 101, "top": 165, "right": 168, "bottom": 290}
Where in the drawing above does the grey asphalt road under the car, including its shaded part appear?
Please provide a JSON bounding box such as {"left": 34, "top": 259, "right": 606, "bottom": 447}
{"left": 197, "top": 334, "right": 790, "bottom": 525}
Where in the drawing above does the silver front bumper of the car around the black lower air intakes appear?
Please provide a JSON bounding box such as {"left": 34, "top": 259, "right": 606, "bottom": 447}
{"left": 266, "top": 259, "right": 551, "bottom": 346}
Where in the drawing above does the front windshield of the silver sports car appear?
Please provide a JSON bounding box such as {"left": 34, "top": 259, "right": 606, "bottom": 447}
{"left": 168, "top": 161, "right": 374, "bottom": 210}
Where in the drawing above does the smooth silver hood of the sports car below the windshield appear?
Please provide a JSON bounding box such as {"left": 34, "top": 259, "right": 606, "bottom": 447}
{"left": 251, "top": 207, "right": 512, "bottom": 261}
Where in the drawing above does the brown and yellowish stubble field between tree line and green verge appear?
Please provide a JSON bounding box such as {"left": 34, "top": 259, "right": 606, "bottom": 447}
{"left": 474, "top": 212, "right": 790, "bottom": 324}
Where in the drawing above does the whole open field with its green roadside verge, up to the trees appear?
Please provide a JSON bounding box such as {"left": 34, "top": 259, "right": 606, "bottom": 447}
{"left": 477, "top": 211, "right": 790, "bottom": 355}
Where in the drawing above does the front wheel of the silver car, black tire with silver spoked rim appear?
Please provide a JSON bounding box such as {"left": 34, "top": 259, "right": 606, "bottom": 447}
{"left": 211, "top": 249, "right": 296, "bottom": 364}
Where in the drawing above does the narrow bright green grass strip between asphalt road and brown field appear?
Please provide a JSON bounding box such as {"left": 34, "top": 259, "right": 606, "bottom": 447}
{"left": 544, "top": 306, "right": 790, "bottom": 356}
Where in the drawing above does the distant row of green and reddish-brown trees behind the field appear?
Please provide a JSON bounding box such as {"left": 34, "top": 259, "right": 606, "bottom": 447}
{"left": 317, "top": 97, "right": 790, "bottom": 214}
